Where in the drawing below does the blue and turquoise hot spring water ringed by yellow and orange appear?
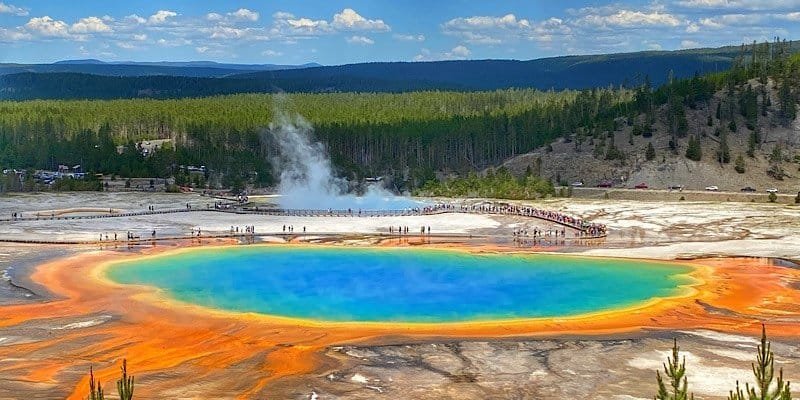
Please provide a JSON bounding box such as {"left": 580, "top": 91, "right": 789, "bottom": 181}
{"left": 108, "top": 246, "right": 690, "bottom": 322}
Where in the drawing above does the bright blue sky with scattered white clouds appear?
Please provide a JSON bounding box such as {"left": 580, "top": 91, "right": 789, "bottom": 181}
{"left": 0, "top": 0, "right": 800, "bottom": 65}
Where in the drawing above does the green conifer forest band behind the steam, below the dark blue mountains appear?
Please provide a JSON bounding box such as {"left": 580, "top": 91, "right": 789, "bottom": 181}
{"left": 0, "top": 41, "right": 800, "bottom": 189}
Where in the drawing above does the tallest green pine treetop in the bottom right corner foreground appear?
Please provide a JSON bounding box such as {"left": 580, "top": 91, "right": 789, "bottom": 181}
{"left": 728, "top": 324, "right": 792, "bottom": 400}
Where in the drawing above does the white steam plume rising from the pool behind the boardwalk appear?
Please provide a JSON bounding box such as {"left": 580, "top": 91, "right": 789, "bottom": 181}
{"left": 268, "top": 109, "right": 418, "bottom": 211}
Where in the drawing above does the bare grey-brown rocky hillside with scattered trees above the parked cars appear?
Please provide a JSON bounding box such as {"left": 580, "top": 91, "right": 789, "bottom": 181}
{"left": 503, "top": 79, "right": 800, "bottom": 193}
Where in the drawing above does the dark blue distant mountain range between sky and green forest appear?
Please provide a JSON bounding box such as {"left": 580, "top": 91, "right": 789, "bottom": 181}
{"left": 0, "top": 42, "right": 800, "bottom": 100}
